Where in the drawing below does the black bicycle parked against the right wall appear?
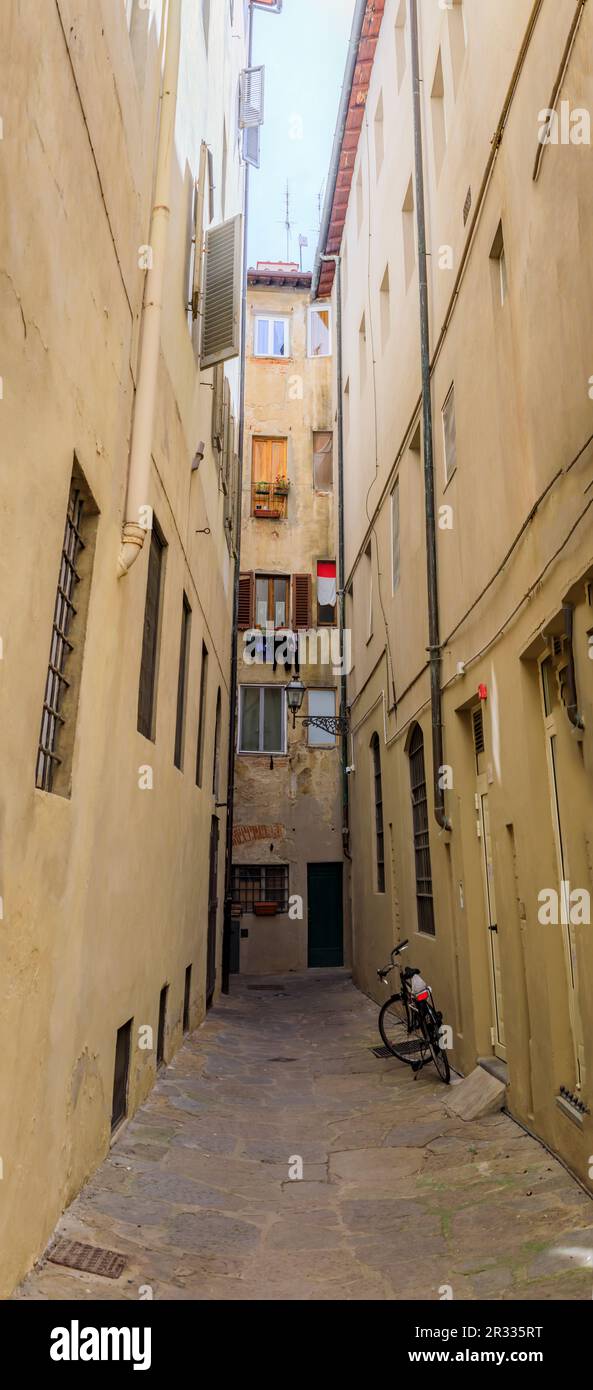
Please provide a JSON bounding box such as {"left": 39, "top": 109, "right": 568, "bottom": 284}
{"left": 376, "top": 941, "right": 451, "bottom": 1086}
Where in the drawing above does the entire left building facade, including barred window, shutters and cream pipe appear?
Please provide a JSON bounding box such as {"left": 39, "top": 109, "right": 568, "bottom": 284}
{"left": 0, "top": 0, "right": 252, "bottom": 1293}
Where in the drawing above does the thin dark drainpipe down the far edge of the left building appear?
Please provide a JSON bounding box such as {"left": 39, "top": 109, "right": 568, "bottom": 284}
{"left": 221, "top": 6, "right": 253, "bottom": 994}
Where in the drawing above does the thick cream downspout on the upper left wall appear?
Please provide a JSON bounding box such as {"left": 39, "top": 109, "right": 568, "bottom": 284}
{"left": 118, "top": 0, "right": 182, "bottom": 578}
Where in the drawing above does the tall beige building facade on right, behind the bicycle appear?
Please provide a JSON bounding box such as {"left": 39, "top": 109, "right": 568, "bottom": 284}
{"left": 318, "top": 0, "right": 593, "bottom": 1184}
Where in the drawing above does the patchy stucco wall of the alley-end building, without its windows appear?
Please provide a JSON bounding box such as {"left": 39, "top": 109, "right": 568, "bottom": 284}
{"left": 233, "top": 286, "right": 347, "bottom": 974}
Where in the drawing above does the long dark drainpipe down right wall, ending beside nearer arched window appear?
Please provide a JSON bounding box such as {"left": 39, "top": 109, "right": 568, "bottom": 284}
{"left": 410, "top": 0, "right": 451, "bottom": 830}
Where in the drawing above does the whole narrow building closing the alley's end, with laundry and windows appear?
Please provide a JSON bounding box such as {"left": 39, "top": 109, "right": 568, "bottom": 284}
{"left": 232, "top": 261, "right": 344, "bottom": 974}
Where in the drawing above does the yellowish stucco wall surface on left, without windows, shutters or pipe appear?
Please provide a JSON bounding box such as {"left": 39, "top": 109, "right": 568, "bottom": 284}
{"left": 0, "top": 0, "right": 244, "bottom": 1293}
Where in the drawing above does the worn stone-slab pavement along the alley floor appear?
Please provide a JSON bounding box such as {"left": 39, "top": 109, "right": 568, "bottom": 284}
{"left": 15, "top": 972, "right": 593, "bottom": 1300}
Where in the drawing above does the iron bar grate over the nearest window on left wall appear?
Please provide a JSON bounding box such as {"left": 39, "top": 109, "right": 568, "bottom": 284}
{"left": 35, "top": 482, "right": 85, "bottom": 791}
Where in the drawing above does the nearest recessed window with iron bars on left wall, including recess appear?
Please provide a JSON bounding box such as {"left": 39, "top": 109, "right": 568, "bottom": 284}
{"left": 35, "top": 460, "right": 97, "bottom": 796}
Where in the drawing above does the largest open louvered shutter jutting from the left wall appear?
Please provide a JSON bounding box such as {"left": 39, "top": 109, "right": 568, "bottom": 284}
{"left": 200, "top": 213, "right": 243, "bottom": 367}
